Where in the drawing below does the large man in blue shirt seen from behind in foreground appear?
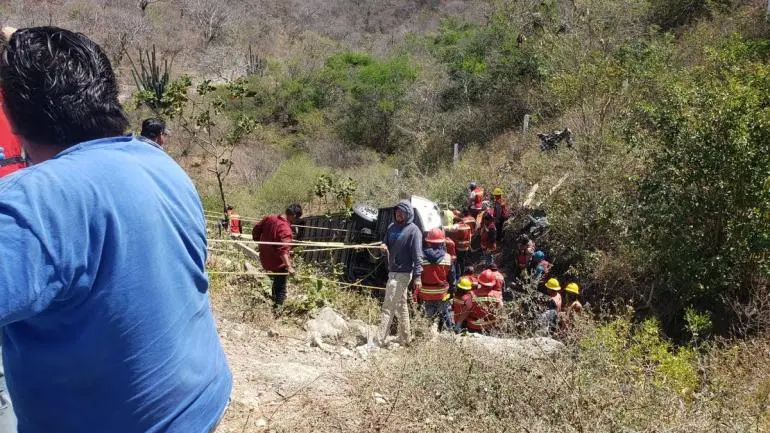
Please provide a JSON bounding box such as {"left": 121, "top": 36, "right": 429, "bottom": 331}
{"left": 0, "top": 27, "right": 232, "bottom": 433}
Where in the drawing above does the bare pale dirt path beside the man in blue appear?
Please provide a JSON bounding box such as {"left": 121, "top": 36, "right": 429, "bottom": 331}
{"left": 210, "top": 318, "right": 365, "bottom": 433}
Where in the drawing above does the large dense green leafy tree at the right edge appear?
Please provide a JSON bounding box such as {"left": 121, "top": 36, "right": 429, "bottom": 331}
{"left": 630, "top": 39, "right": 770, "bottom": 328}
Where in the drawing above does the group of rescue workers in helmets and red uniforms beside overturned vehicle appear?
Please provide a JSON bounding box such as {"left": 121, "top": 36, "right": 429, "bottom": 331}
{"left": 413, "top": 183, "right": 583, "bottom": 334}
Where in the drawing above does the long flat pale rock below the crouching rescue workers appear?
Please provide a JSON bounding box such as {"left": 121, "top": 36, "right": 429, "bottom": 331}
{"left": 456, "top": 334, "right": 565, "bottom": 359}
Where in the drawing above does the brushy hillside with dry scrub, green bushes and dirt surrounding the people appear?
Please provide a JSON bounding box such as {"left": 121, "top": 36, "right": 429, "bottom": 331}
{"left": 0, "top": 0, "right": 770, "bottom": 432}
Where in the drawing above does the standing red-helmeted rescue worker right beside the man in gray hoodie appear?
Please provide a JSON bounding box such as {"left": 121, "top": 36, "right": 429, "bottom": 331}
{"left": 414, "top": 228, "right": 454, "bottom": 331}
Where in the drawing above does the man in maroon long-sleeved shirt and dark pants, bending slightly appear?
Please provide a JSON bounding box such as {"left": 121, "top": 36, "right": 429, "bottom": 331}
{"left": 251, "top": 203, "right": 302, "bottom": 317}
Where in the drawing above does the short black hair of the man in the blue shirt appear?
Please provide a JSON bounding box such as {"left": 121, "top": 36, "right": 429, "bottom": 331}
{"left": 0, "top": 27, "right": 128, "bottom": 147}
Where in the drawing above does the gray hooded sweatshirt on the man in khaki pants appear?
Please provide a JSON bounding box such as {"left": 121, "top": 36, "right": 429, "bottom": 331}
{"left": 382, "top": 200, "right": 422, "bottom": 277}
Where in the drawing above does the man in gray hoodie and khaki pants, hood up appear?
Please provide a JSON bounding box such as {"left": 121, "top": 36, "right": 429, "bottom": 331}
{"left": 377, "top": 200, "right": 422, "bottom": 345}
